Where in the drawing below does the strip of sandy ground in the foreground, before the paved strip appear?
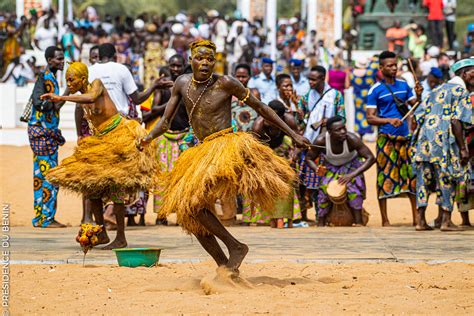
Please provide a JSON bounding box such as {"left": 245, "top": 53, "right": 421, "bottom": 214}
{"left": 10, "top": 262, "right": 474, "bottom": 315}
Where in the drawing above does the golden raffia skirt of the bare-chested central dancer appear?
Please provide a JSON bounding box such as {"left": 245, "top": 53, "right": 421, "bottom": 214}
{"left": 160, "top": 129, "right": 296, "bottom": 236}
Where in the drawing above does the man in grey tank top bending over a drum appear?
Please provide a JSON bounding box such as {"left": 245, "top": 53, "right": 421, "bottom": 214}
{"left": 306, "top": 115, "right": 375, "bottom": 226}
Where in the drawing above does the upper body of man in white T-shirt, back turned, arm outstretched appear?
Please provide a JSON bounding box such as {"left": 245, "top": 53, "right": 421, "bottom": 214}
{"left": 89, "top": 43, "right": 173, "bottom": 116}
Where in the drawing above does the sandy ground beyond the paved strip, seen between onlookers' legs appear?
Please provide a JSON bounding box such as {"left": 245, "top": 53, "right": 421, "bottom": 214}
{"left": 0, "top": 142, "right": 460, "bottom": 226}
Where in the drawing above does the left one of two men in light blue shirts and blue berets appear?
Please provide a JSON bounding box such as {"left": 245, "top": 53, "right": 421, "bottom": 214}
{"left": 248, "top": 57, "right": 278, "bottom": 104}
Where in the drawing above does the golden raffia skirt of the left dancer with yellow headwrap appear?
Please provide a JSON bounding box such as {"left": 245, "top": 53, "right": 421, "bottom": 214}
{"left": 47, "top": 114, "right": 158, "bottom": 200}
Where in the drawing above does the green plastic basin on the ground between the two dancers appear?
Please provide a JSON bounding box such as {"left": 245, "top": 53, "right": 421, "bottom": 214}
{"left": 113, "top": 248, "right": 161, "bottom": 268}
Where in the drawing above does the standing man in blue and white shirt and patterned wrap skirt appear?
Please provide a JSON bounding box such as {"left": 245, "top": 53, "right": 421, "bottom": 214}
{"left": 367, "top": 51, "right": 423, "bottom": 226}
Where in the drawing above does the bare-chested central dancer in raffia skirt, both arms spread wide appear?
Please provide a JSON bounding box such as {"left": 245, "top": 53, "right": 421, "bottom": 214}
{"left": 139, "top": 40, "right": 310, "bottom": 272}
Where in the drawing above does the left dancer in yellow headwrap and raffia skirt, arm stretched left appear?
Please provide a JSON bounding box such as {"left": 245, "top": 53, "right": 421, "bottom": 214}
{"left": 42, "top": 62, "right": 157, "bottom": 249}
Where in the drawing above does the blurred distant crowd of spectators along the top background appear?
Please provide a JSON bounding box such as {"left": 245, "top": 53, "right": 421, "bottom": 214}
{"left": 0, "top": 0, "right": 474, "bottom": 87}
